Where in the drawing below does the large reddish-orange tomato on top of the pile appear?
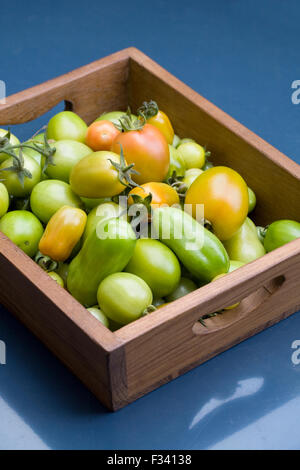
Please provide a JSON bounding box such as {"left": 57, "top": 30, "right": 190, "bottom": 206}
{"left": 111, "top": 123, "right": 170, "bottom": 184}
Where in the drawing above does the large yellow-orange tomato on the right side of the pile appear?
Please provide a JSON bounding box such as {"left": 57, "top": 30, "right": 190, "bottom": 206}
{"left": 185, "top": 166, "right": 249, "bottom": 240}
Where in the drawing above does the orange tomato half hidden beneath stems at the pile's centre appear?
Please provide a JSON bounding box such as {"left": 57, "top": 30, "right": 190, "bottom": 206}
{"left": 128, "top": 181, "right": 179, "bottom": 207}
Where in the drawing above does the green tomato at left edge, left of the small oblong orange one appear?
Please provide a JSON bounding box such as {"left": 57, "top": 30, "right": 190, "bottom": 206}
{"left": 0, "top": 211, "right": 44, "bottom": 257}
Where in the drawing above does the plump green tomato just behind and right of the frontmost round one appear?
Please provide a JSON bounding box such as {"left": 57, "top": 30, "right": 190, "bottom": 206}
{"left": 125, "top": 238, "right": 181, "bottom": 298}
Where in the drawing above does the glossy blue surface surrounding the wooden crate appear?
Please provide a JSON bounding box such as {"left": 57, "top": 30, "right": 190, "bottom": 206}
{"left": 0, "top": 0, "right": 300, "bottom": 449}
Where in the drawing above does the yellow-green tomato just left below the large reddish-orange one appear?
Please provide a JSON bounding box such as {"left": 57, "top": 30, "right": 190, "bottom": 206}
{"left": 70, "top": 151, "right": 125, "bottom": 198}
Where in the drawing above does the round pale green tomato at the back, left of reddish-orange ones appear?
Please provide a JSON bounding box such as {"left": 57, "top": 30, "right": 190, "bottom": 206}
{"left": 47, "top": 111, "right": 87, "bottom": 143}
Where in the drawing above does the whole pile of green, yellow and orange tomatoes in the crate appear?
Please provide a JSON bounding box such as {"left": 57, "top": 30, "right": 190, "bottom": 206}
{"left": 0, "top": 101, "right": 300, "bottom": 330}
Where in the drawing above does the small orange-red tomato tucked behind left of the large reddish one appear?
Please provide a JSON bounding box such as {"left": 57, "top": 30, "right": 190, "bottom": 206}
{"left": 85, "top": 120, "right": 120, "bottom": 151}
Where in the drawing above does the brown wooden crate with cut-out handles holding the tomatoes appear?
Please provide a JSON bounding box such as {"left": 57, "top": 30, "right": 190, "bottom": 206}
{"left": 0, "top": 48, "right": 300, "bottom": 410}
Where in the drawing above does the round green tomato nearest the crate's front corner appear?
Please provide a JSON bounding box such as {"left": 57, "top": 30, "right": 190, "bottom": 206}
{"left": 97, "top": 272, "right": 153, "bottom": 325}
